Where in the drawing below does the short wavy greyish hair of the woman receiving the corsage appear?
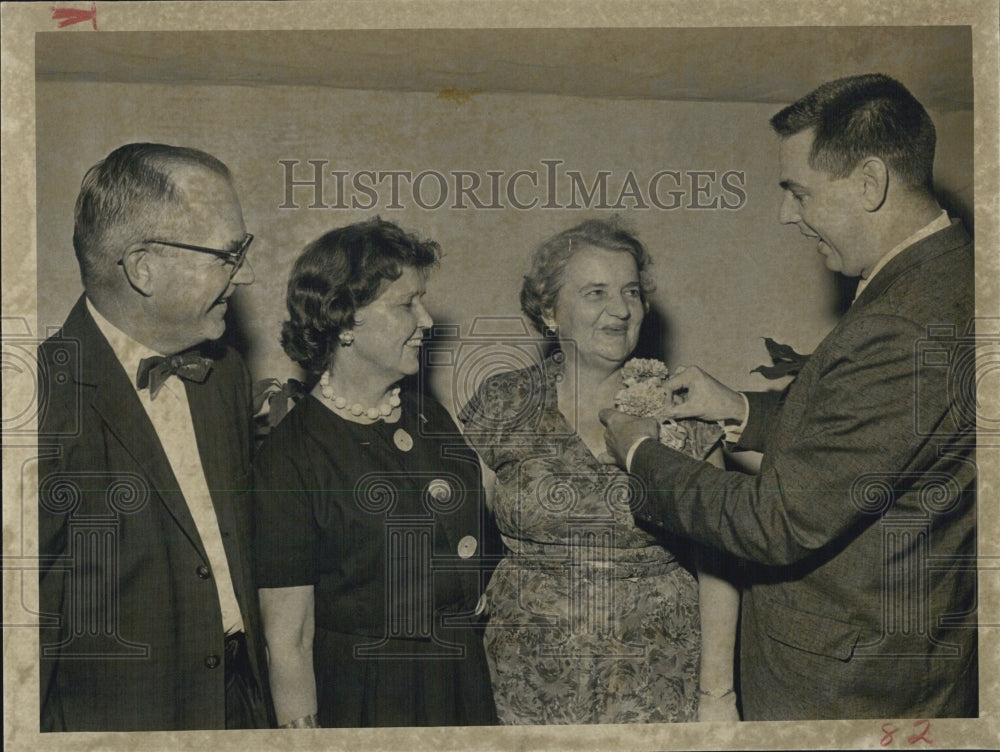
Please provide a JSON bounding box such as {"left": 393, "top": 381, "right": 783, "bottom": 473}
{"left": 521, "top": 217, "right": 655, "bottom": 334}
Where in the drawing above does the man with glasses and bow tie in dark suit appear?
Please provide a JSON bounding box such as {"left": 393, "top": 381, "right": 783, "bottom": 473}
{"left": 38, "top": 144, "right": 273, "bottom": 731}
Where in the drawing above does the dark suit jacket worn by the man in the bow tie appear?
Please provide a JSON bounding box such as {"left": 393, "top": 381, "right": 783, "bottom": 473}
{"left": 38, "top": 297, "right": 274, "bottom": 731}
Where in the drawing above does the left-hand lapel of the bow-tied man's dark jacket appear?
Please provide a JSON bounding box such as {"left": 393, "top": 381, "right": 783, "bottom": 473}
{"left": 63, "top": 297, "right": 206, "bottom": 558}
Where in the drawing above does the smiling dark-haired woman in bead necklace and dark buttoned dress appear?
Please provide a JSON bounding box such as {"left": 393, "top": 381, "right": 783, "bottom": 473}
{"left": 253, "top": 217, "right": 497, "bottom": 728}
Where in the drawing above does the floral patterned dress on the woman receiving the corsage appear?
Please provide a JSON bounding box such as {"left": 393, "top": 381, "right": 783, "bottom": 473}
{"left": 460, "top": 353, "right": 701, "bottom": 724}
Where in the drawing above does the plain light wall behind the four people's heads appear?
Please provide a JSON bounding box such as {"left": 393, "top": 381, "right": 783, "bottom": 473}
{"left": 36, "top": 81, "right": 974, "bottom": 418}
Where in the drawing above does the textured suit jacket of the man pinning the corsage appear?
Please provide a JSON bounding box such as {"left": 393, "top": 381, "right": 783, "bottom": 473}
{"left": 632, "top": 222, "right": 977, "bottom": 720}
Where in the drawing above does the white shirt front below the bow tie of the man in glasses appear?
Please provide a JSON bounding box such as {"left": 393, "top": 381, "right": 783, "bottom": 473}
{"left": 87, "top": 298, "right": 243, "bottom": 634}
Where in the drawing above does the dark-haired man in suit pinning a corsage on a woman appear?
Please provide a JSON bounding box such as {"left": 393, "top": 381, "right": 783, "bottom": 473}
{"left": 602, "top": 75, "right": 978, "bottom": 720}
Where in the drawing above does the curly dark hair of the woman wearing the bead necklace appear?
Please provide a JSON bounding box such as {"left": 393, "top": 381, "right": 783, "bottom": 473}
{"left": 281, "top": 217, "right": 440, "bottom": 374}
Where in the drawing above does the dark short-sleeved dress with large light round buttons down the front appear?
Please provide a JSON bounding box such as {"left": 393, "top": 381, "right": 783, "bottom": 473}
{"left": 254, "top": 392, "right": 496, "bottom": 727}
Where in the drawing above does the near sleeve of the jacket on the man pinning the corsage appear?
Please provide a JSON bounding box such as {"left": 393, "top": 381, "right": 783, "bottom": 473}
{"left": 632, "top": 316, "right": 957, "bottom": 565}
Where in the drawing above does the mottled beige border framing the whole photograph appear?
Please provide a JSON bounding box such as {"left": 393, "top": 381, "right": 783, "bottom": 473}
{"left": 0, "top": 0, "right": 1000, "bottom": 752}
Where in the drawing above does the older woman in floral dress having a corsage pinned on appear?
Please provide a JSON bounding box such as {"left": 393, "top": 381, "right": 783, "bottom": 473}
{"left": 460, "top": 220, "right": 738, "bottom": 724}
